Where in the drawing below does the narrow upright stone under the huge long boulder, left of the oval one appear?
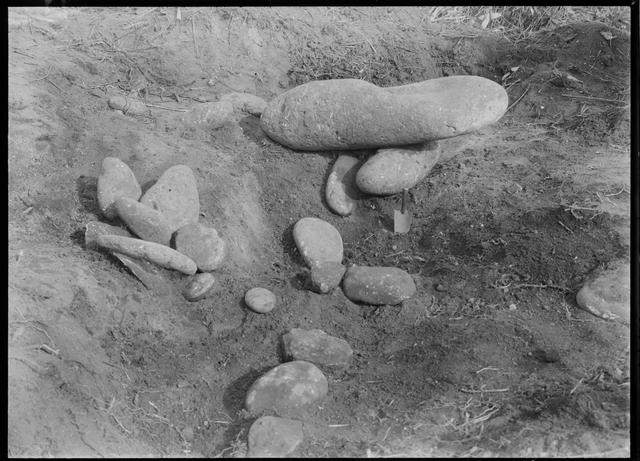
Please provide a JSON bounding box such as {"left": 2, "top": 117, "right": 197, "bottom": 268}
{"left": 325, "top": 155, "right": 361, "bottom": 216}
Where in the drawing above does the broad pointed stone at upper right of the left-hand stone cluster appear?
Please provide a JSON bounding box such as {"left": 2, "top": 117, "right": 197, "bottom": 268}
{"left": 140, "top": 165, "right": 200, "bottom": 232}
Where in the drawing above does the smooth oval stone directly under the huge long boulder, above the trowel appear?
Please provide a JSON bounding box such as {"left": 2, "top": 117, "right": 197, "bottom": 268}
{"left": 356, "top": 141, "right": 440, "bottom": 195}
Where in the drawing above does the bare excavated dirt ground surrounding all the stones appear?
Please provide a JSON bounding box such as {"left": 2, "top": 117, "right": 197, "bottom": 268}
{"left": 8, "top": 8, "right": 630, "bottom": 457}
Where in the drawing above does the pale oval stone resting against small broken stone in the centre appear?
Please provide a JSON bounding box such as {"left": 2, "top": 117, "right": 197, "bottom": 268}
{"left": 293, "top": 217, "right": 343, "bottom": 268}
